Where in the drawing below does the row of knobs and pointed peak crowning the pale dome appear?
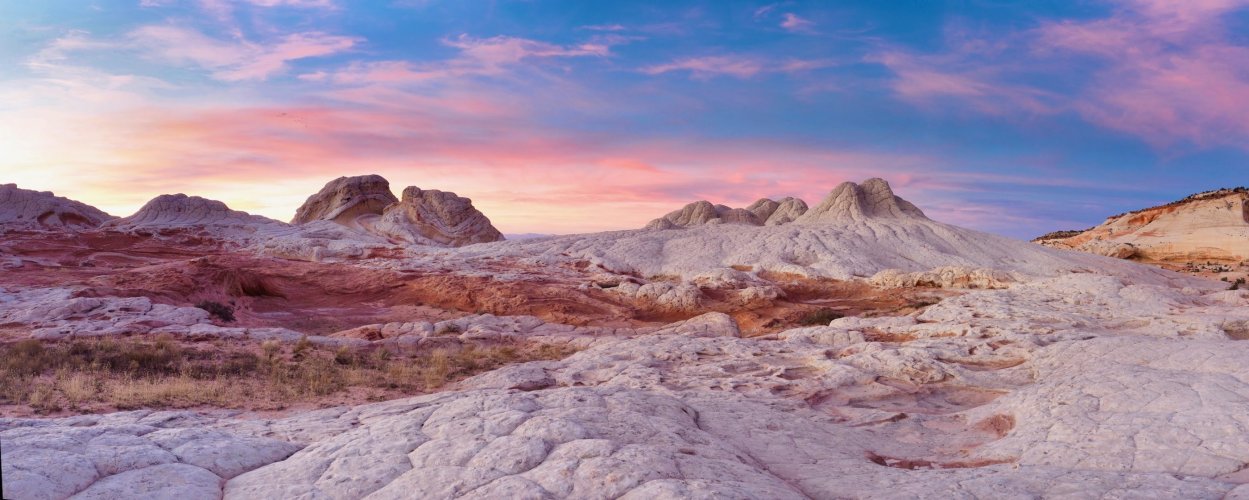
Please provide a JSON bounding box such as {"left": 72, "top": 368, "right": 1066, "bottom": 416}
{"left": 646, "top": 179, "right": 928, "bottom": 229}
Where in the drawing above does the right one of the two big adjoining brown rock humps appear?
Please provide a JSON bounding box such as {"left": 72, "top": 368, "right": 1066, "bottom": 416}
{"left": 375, "top": 186, "right": 503, "bottom": 246}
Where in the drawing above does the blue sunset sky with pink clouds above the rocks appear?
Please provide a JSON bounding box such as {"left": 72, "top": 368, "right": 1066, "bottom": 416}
{"left": 0, "top": 0, "right": 1249, "bottom": 238}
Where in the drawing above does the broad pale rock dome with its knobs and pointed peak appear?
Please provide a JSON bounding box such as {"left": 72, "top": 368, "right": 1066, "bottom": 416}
{"left": 469, "top": 179, "right": 1177, "bottom": 283}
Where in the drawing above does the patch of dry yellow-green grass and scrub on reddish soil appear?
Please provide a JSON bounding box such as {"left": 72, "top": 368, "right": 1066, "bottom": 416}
{"left": 0, "top": 338, "right": 573, "bottom": 414}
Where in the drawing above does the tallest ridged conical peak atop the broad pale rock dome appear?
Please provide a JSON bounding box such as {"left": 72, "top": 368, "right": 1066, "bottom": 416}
{"left": 794, "top": 179, "right": 928, "bottom": 224}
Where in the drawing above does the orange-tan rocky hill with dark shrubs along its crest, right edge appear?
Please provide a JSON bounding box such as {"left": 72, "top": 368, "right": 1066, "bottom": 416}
{"left": 1034, "top": 188, "right": 1249, "bottom": 264}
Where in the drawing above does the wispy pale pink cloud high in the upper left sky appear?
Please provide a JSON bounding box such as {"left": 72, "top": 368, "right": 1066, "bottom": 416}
{"left": 126, "top": 24, "right": 361, "bottom": 81}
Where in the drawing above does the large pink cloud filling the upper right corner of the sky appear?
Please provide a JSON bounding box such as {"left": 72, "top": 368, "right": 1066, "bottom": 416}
{"left": 1038, "top": 0, "right": 1249, "bottom": 146}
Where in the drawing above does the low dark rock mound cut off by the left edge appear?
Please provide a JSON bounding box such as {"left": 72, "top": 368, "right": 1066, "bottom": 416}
{"left": 0, "top": 184, "right": 115, "bottom": 230}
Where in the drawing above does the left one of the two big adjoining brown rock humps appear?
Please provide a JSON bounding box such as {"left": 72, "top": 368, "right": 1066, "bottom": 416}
{"left": 291, "top": 175, "right": 398, "bottom": 226}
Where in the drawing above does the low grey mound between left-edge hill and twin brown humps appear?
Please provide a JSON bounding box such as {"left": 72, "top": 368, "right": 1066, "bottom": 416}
{"left": 104, "top": 194, "right": 285, "bottom": 230}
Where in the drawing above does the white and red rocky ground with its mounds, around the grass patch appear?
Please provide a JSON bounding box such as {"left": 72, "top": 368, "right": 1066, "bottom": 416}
{"left": 0, "top": 178, "right": 1249, "bottom": 499}
